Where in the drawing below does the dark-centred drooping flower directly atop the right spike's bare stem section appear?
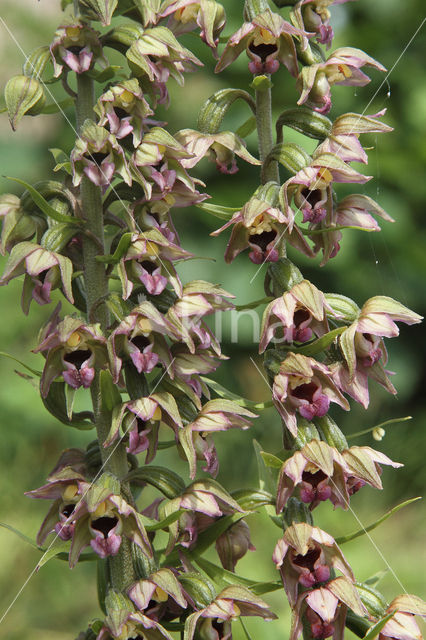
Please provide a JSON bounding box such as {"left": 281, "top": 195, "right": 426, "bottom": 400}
{"left": 216, "top": 9, "right": 307, "bottom": 76}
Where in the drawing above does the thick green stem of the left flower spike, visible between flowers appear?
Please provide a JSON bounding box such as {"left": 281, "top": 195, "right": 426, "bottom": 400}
{"left": 76, "top": 65, "right": 135, "bottom": 591}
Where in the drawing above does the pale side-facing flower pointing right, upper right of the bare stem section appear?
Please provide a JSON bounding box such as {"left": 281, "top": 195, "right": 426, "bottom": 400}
{"left": 297, "top": 47, "right": 386, "bottom": 113}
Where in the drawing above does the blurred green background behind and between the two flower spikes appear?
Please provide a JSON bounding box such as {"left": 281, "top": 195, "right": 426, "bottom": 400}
{"left": 0, "top": 0, "right": 426, "bottom": 640}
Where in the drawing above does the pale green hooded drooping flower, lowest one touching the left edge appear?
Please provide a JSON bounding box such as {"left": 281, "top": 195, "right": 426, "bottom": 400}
{"left": 0, "top": 242, "right": 74, "bottom": 314}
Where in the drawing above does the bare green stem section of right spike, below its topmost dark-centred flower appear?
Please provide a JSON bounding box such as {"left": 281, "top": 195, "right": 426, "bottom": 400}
{"left": 256, "top": 81, "right": 280, "bottom": 184}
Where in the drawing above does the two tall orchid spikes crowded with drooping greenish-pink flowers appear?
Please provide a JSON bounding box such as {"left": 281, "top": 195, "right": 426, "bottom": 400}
{"left": 0, "top": 0, "right": 425, "bottom": 640}
